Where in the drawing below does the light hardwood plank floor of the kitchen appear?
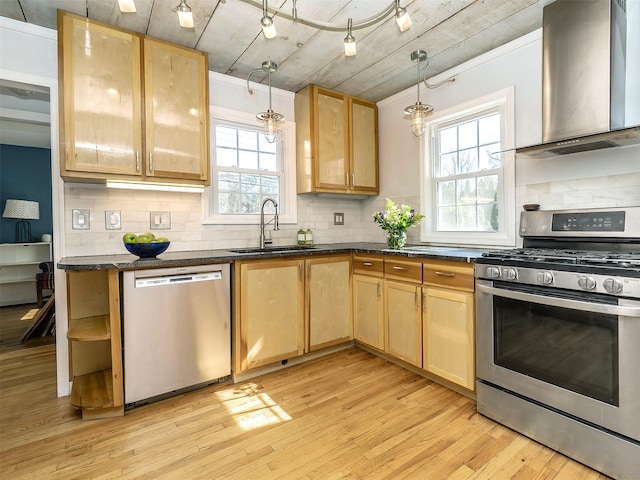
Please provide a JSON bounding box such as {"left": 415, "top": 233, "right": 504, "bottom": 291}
{"left": 0, "top": 345, "right": 607, "bottom": 480}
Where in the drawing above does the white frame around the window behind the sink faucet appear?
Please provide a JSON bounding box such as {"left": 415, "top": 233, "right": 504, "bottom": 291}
{"left": 202, "top": 107, "right": 298, "bottom": 225}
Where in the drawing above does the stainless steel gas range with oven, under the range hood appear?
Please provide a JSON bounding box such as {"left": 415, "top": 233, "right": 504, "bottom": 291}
{"left": 476, "top": 207, "right": 640, "bottom": 479}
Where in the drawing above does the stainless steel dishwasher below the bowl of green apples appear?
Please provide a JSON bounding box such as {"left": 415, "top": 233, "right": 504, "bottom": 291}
{"left": 122, "top": 264, "right": 231, "bottom": 407}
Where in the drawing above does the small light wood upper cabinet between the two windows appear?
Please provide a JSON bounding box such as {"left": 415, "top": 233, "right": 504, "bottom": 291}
{"left": 295, "top": 85, "right": 379, "bottom": 195}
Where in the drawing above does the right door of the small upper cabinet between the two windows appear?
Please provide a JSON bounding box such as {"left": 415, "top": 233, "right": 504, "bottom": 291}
{"left": 349, "top": 98, "right": 379, "bottom": 194}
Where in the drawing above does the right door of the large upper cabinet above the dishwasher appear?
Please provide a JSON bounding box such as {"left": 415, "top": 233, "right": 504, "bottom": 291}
{"left": 144, "top": 38, "right": 209, "bottom": 182}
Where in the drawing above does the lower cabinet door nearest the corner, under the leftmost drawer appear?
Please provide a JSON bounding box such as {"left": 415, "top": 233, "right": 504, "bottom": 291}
{"left": 353, "top": 275, "right": 384, "bottom": 350}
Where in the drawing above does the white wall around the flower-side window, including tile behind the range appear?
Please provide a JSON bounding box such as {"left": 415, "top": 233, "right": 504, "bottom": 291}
{"left": 372, "top": 30, "right": 640, "bottom": 244}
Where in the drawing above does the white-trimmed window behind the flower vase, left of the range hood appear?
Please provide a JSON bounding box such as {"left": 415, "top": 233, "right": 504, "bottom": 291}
{"left": 421, "top": 89, "right": 515, "bottom": 246}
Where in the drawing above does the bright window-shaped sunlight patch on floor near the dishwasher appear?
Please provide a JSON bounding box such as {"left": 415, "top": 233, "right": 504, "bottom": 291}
{"left": 216, "top": 383, "right": 291, "bottom": 430}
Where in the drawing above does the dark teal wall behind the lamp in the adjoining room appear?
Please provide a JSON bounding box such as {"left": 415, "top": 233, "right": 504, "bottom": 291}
{"left": 0, "top": 145, "right": 53, "bottom": 243}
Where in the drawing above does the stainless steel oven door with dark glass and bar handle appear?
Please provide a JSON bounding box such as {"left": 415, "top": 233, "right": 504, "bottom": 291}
{"left": 476, "top": 280, "right": 640, "bottom": 441}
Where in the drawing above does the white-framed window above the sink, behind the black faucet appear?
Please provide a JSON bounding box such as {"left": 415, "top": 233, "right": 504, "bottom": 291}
{"left": 203, "top": 108, "right": 296, "bottom": 224}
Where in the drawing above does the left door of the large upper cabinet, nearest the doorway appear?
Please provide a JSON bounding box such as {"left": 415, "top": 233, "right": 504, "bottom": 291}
{"left": 58, "top": 12, "right": 143, "bottom": 177}
